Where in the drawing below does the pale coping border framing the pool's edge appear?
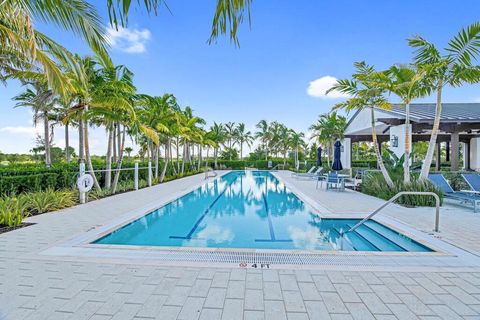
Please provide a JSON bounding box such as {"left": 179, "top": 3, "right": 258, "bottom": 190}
{"left": 39, "top": 170, "right": 480, "bottom": 266}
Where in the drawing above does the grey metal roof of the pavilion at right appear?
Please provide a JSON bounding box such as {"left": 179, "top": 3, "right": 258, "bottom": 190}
{"left": 382, "top": 103, "right": 480, "bottom": 123}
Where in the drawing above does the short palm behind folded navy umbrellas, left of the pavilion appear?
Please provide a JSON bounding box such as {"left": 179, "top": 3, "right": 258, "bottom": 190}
{"left": 309, "top": 111, "right": 347, "bottom": 166}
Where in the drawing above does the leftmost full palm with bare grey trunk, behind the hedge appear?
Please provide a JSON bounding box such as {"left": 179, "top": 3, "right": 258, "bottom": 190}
{"left": 13, "top": 81, "right": 55, "bottom": 167}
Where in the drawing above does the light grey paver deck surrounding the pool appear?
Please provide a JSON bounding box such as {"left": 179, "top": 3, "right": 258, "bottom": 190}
{"left": 0, "top": 171, "right": 480, "bottom": 320}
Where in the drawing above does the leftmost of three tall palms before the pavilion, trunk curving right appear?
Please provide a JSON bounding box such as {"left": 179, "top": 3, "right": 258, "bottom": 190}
{"left": 327, "top": 61, "right": 394, "bottom": 188}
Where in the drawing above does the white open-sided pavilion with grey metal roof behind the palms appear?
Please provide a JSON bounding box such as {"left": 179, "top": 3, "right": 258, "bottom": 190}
{"left": 342, "top": 103, "right": 480, "bottom": 171}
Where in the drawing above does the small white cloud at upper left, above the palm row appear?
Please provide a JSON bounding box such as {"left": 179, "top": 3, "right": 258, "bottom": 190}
{"left": 107, "top": 27, "right": 151, "bottom": 53}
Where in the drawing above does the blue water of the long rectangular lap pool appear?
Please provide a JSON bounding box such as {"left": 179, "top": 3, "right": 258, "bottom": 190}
{"left": 95, "top": 171, "right": 431, "bottom": 251}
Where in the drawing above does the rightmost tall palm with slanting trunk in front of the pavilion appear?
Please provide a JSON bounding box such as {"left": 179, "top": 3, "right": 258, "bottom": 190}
{"left": 408, "top": 22, "right": 480, "bottom": 179}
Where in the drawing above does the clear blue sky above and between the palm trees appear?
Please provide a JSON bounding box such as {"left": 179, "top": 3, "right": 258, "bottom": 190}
{"left": 0, "top": 0, "right": 480, "bottom": 154}
